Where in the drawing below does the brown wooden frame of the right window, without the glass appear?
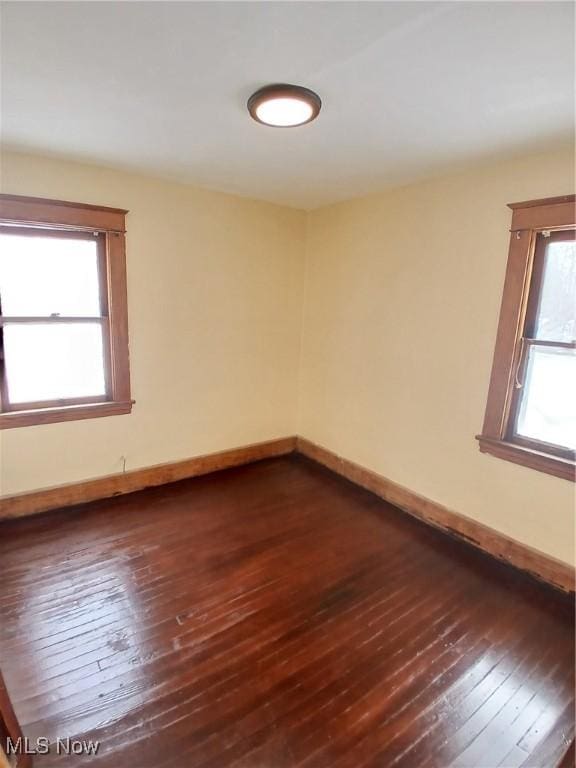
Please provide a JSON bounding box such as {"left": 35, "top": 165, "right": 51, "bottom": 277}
{"left": 477, "top": 195, "right": 576, "bottom": 481}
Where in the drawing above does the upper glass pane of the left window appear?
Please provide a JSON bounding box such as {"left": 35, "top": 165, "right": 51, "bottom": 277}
{"left": 0, "top": 233, "right": 100, "bottom": 317}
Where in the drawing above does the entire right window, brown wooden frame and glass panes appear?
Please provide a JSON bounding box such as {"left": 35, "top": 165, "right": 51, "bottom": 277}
{"left": 478, "top": 196, "right": 576, "bottom": 480}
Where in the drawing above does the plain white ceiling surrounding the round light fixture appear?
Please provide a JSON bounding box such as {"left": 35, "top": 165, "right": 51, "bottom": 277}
{"left": 1, "top": 2, "right": 574, "bottom": 208}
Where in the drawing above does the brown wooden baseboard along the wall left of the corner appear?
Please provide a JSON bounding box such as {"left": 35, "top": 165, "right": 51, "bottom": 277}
{"left": 0, "top": 437, "right": 296, "bottom": 520}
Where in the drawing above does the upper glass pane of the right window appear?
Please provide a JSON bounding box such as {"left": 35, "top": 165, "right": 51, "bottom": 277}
{"left": 536, "top": 240, "right": 576, "bottom": 341}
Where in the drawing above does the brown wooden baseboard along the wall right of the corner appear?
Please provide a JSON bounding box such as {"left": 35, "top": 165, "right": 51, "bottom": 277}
{"left": 296, "top": 437, "right": 575, "bottom": 592}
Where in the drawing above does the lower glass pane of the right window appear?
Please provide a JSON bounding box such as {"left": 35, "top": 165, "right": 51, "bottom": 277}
{"left": 516, "top": 346, "right": 576, "bottom": 449}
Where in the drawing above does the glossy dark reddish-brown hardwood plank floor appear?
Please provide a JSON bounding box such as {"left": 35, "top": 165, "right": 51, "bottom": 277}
{"left": 0, "top": 457, "right": 574, "bottom": 768}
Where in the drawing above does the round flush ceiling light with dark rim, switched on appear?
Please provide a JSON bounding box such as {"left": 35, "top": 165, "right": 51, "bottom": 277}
{"left": 247, "top": 83, "right": 322, "bottom": 128}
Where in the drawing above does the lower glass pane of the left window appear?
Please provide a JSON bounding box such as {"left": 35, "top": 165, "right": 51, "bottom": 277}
{"left": 4, "top": 323, "right": 106, "bottom": 403}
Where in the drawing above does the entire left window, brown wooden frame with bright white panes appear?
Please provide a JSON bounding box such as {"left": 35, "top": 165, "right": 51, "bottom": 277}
{"left": 0, "top": 195, "right": 132, "bottom": 429}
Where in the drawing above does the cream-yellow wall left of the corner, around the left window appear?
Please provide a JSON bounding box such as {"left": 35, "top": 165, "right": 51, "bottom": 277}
{"left": 0, "top": 154, "right": 305, "bottom": 495}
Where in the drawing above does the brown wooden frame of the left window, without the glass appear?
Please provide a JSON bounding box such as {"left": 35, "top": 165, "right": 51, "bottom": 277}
{"left": 0, "top": 195, "right": 134, "bottom": 429}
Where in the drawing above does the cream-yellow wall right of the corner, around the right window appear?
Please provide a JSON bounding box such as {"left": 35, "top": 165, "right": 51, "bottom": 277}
{"left": 299, "top": 151, "right": 574, "bottom": 562}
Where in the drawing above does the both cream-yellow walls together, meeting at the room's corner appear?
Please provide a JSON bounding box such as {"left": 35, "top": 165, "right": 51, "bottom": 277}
{"left": 0, "top": 146, "right": 574, "bottom": 562}
